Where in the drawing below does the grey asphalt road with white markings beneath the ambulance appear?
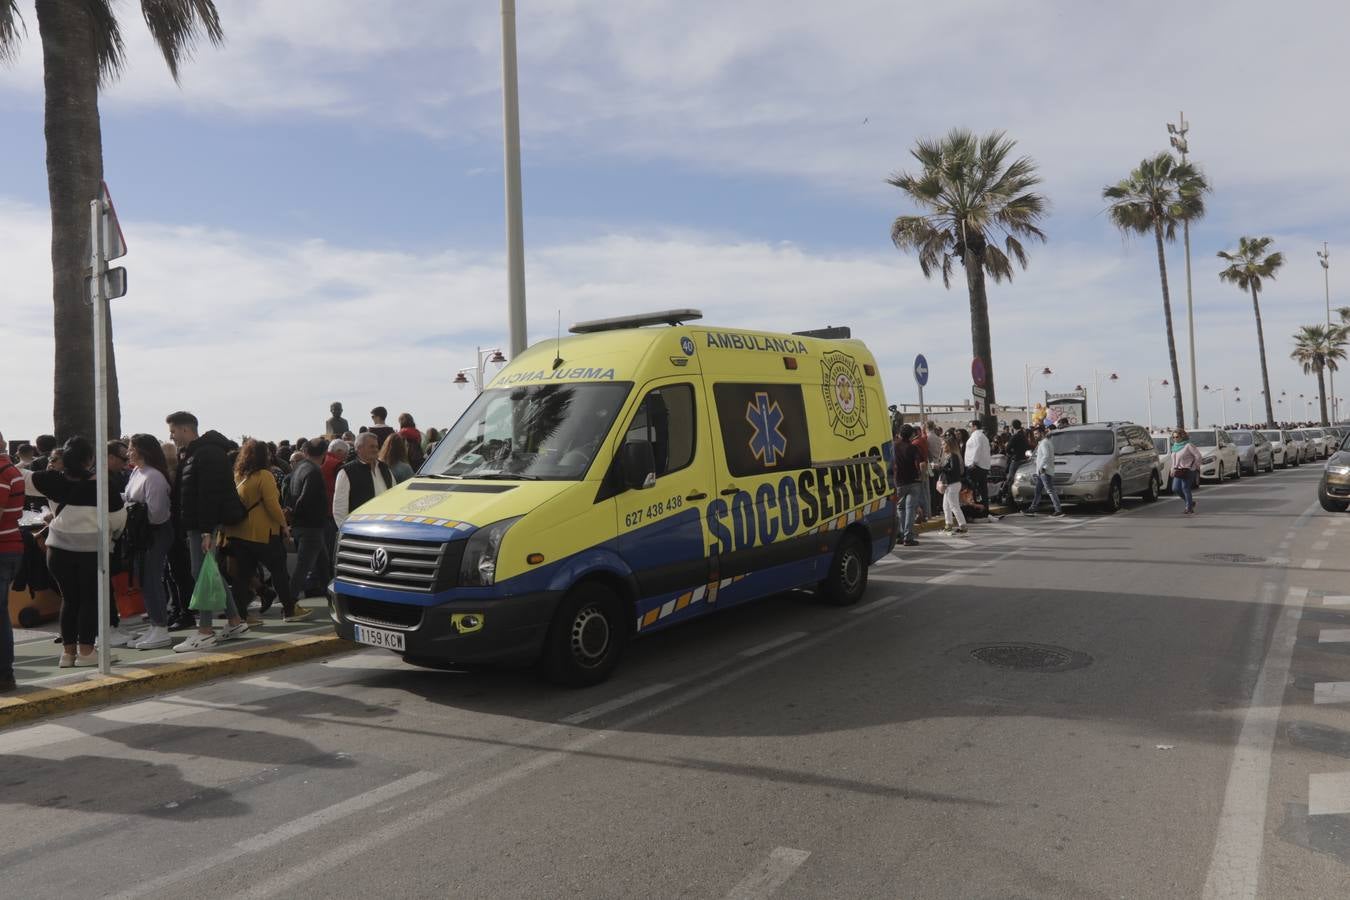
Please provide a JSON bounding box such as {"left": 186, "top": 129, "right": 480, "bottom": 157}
{"left": 0, "top": 467, "right": 1350, "bottom": 900}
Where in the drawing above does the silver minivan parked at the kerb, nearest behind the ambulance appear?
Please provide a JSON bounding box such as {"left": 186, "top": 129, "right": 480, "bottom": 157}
{"left": 1013, "top": 422, "right": 1165, "bottom": 513}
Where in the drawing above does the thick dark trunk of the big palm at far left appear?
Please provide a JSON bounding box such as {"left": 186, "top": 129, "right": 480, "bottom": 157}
{"left": 36, "top": 0, "right": 122, "bottom": 443}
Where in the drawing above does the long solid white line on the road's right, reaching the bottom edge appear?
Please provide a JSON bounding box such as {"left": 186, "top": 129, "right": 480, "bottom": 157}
{"left": 1203, "top": 584, "right": 1308, "bottom": 900}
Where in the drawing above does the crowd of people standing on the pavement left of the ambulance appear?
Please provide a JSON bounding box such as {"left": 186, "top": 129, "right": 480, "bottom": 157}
{"left": 0, "top": 403, "right": 440, "bottom": 691}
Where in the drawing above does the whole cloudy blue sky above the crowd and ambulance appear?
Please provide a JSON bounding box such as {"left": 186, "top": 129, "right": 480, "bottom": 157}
{"left": 0, "top": 0, "right": 1350, "bottom": 440}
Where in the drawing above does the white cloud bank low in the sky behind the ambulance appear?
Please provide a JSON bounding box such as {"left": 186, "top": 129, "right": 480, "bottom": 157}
{"left": 0, "top": 194, "right": 1339, "bottom": 439}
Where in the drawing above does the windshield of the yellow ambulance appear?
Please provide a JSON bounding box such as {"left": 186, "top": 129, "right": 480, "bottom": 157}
{"left": 419, "top": 382, "right": 632, "bottom": 482}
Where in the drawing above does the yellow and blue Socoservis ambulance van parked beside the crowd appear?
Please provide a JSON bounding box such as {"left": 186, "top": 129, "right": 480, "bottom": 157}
{"left": 331, "top": 309, "right": 896, "bottom": 685}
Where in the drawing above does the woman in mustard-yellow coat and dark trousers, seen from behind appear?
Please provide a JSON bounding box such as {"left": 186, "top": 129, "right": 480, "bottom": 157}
{"left": 224, "top": 439, "right": 309, "bottom": 622}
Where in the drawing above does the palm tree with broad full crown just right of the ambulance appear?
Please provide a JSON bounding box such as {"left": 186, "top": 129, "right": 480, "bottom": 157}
{"left": 887, "top": 128, "right": 1046, "bottom": 437}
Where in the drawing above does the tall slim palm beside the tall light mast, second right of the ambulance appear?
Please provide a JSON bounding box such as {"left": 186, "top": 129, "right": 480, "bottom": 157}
{"left": 1102, "top": 152, "right": 1210, "bottom": 428}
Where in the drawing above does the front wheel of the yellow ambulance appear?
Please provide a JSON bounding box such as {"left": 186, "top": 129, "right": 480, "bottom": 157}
{"left": 540, "top": 582, "right": 628, "bottom": 687}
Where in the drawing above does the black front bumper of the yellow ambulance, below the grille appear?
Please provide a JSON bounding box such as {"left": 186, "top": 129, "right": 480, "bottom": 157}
{"left": 331, "top": 582, "right": 562, "bottom": 665}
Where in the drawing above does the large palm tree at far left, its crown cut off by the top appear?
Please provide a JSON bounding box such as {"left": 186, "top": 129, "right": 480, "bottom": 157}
{"left": 0, "top": 0, "right": 224, "bottom": 439}
